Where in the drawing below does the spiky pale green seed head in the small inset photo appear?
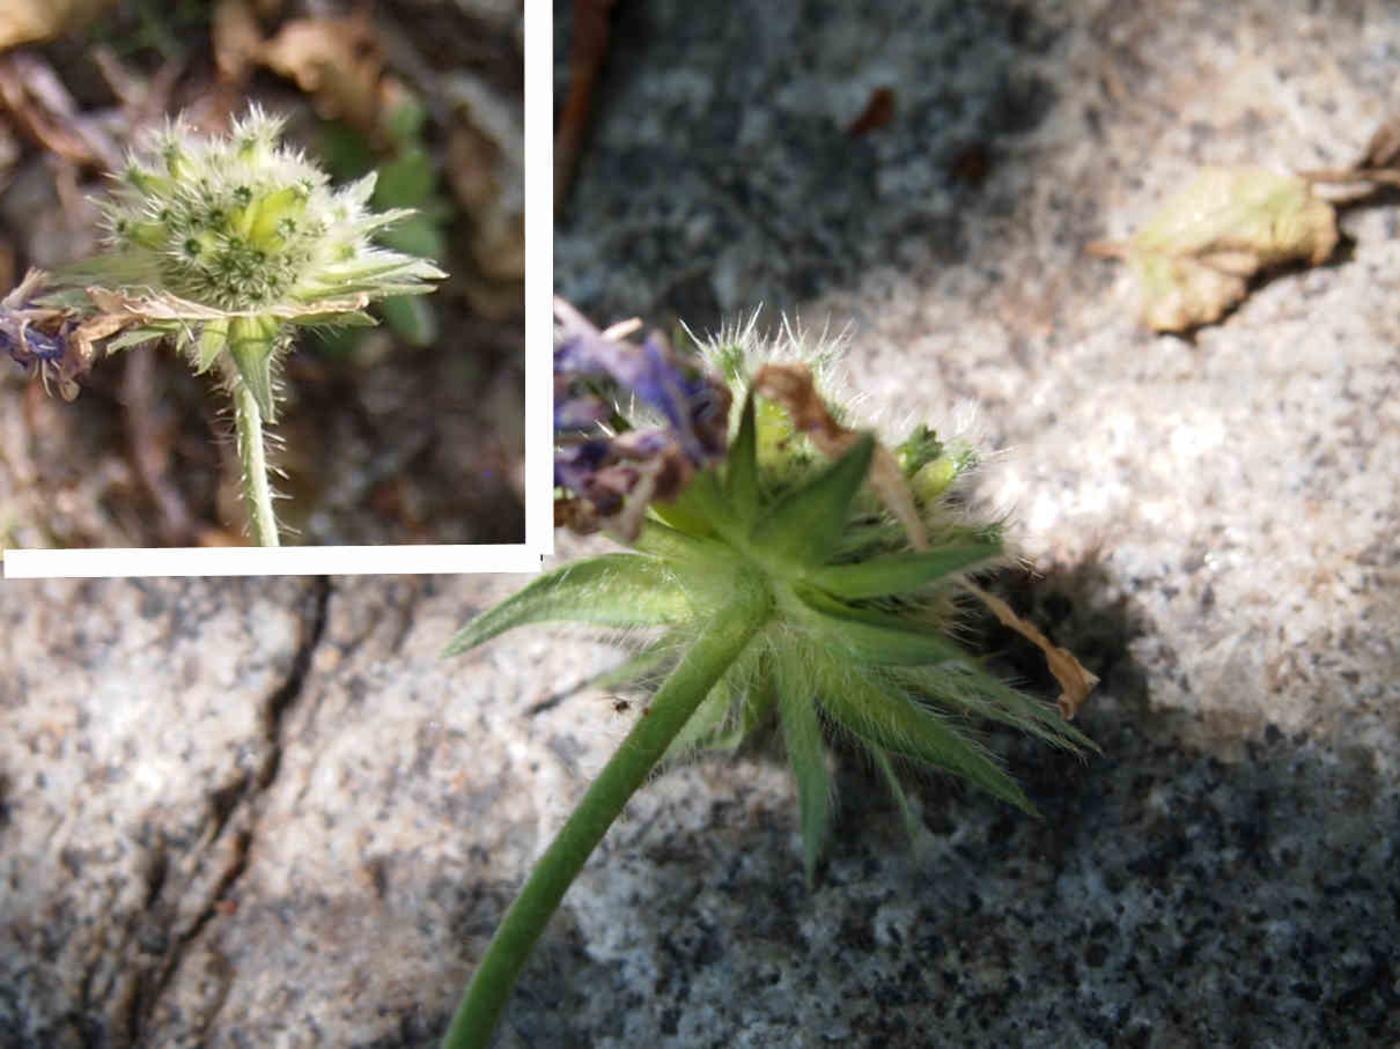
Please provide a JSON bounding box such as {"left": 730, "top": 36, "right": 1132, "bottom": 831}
{"left": 57, "top": 108, "right": 444, "bottom": 416}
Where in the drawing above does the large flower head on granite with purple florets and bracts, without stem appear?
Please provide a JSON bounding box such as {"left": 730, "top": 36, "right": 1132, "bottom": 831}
{"left": 452, "top": 308, "right": 1092, "bottom": 877}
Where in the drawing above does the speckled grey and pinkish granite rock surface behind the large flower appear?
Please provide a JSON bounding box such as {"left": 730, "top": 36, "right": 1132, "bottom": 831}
{"left": 8, "top": 0, "right": 1400, "bottom": 1049}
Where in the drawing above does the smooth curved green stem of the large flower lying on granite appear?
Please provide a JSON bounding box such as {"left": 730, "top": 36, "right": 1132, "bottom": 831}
{"left": 442, "top": 598, "right": 767, "bottom": 1049}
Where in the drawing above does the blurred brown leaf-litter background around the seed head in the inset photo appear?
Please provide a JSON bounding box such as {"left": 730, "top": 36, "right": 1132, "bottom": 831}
{"left": 0, "top": 0, "right": 524, "bottom": 546}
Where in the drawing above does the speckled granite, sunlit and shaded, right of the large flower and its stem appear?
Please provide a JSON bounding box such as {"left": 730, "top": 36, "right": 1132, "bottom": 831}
{"left": 551, "top": 0, "right": 1400, "bottom": 1046}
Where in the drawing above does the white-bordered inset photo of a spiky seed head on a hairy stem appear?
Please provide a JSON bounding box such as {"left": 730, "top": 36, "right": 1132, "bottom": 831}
{"left": 0, "top": 0, "right": 525, "bottom": 550}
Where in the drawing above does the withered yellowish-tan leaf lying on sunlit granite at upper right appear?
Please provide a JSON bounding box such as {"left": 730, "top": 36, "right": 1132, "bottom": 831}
{"left": 1089, "top": 167, "right": 1337, "bottom": 332}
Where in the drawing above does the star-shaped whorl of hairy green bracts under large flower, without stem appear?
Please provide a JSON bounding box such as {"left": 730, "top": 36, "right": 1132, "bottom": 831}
{"left": 449, "top": 395, "right": 1091, "bottom": 878}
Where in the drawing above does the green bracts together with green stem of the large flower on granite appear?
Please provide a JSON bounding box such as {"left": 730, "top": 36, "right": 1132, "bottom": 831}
{"left": 442, "top": 336, "right": 1092, "bottom": 1049}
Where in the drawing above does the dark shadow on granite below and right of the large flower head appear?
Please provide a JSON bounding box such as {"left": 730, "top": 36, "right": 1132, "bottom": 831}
{"left": 508, "top": 551, "right": 1400, "bottom": 1049}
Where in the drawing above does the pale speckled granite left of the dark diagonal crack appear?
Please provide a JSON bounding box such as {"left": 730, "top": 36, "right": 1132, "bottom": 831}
{"left": 0, "top": 581, "right": 318, "bottom": 1049}
